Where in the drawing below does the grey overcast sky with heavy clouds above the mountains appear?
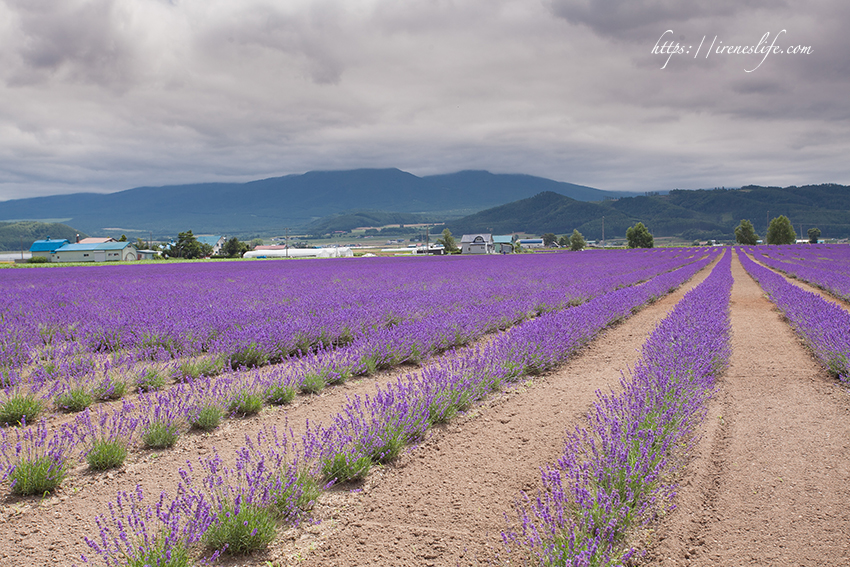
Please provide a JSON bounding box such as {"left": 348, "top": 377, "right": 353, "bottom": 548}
{"left": 0, "top": 0, "right": 850, "bottom": 200}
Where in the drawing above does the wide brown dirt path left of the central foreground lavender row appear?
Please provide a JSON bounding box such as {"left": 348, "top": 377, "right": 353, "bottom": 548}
{"left": 274, "top": 260, "right": 724, "bottom": 567}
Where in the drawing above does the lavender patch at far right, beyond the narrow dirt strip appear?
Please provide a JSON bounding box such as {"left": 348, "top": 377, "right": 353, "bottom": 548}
{"left": 746, "top": 244, "right": 850, "bottom": 301}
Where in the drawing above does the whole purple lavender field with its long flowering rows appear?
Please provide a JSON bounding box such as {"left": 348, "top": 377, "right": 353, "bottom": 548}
{"left": 0, "top": 249, "right": 847, "bottom": 566}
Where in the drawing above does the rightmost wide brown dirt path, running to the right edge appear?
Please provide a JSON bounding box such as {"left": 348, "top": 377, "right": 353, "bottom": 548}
{"left": 645, "top": 253, "right": 850, "bottom": 566}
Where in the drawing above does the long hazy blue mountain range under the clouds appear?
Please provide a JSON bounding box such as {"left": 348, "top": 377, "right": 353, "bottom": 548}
{"left": 0, "top": 169, "right": 624, "bottom": 238}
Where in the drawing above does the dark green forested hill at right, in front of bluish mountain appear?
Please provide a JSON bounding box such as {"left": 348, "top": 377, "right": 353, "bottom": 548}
{"left": 446, "top": 184, "right": 850, "bottom": 240}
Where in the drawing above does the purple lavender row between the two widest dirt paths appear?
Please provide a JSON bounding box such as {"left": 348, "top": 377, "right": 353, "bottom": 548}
{"left": 503, "top": 253, "right": 732, "bottom": 567}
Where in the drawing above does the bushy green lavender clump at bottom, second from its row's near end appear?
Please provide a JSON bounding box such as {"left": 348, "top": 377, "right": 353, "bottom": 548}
{"left": 204, "top": 504, "right": 276, "bottom": 555}
